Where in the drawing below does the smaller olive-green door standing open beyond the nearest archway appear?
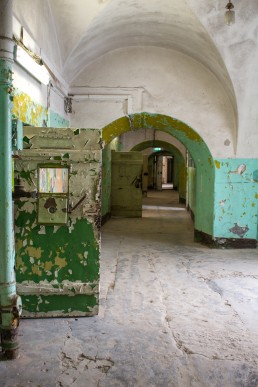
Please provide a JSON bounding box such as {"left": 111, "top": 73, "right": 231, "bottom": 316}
{"left": 111, "top": 151, "right": 143, "bottom": 218}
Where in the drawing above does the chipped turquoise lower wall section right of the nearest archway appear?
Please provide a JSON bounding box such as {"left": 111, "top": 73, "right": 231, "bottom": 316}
{"left": 214, "top": 159, "right": 258, "bottom": 239}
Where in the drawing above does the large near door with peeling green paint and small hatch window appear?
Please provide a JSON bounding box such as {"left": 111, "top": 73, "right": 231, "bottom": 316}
{"left": 14, "top": 127, "right": 101, "bottom": 317}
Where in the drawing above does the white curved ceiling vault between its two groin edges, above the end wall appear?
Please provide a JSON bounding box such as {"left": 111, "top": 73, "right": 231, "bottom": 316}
{"left": 14, "top": 0, "right": 236, "bottom": 89}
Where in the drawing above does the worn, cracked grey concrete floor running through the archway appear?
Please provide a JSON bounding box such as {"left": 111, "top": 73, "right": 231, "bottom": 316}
{"left": 0, "top": 190, "right": 258, "bottom": 387}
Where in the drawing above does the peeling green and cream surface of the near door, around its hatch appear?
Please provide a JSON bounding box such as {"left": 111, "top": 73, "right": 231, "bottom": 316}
{"left": 15, "top": 127, "right": 101, "bottom": 316}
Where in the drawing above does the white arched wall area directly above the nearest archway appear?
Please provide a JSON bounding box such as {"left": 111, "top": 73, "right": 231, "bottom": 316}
{"left": 71, "top": 47, "right": 236, "bottom": 158}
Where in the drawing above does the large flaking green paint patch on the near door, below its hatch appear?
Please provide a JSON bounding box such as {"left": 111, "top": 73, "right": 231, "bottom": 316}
{"left": 16, "top": 215, "right": 99, "bottom": 283}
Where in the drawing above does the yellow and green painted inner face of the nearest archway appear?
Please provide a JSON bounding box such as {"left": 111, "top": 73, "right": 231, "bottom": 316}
{"left": 102, "top": 112, "right": 214, "bottom": 244}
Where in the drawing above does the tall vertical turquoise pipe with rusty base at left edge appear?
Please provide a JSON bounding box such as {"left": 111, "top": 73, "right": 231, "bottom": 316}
{"left": 0, "top": 0, "right": 21, "bottom": 359}
